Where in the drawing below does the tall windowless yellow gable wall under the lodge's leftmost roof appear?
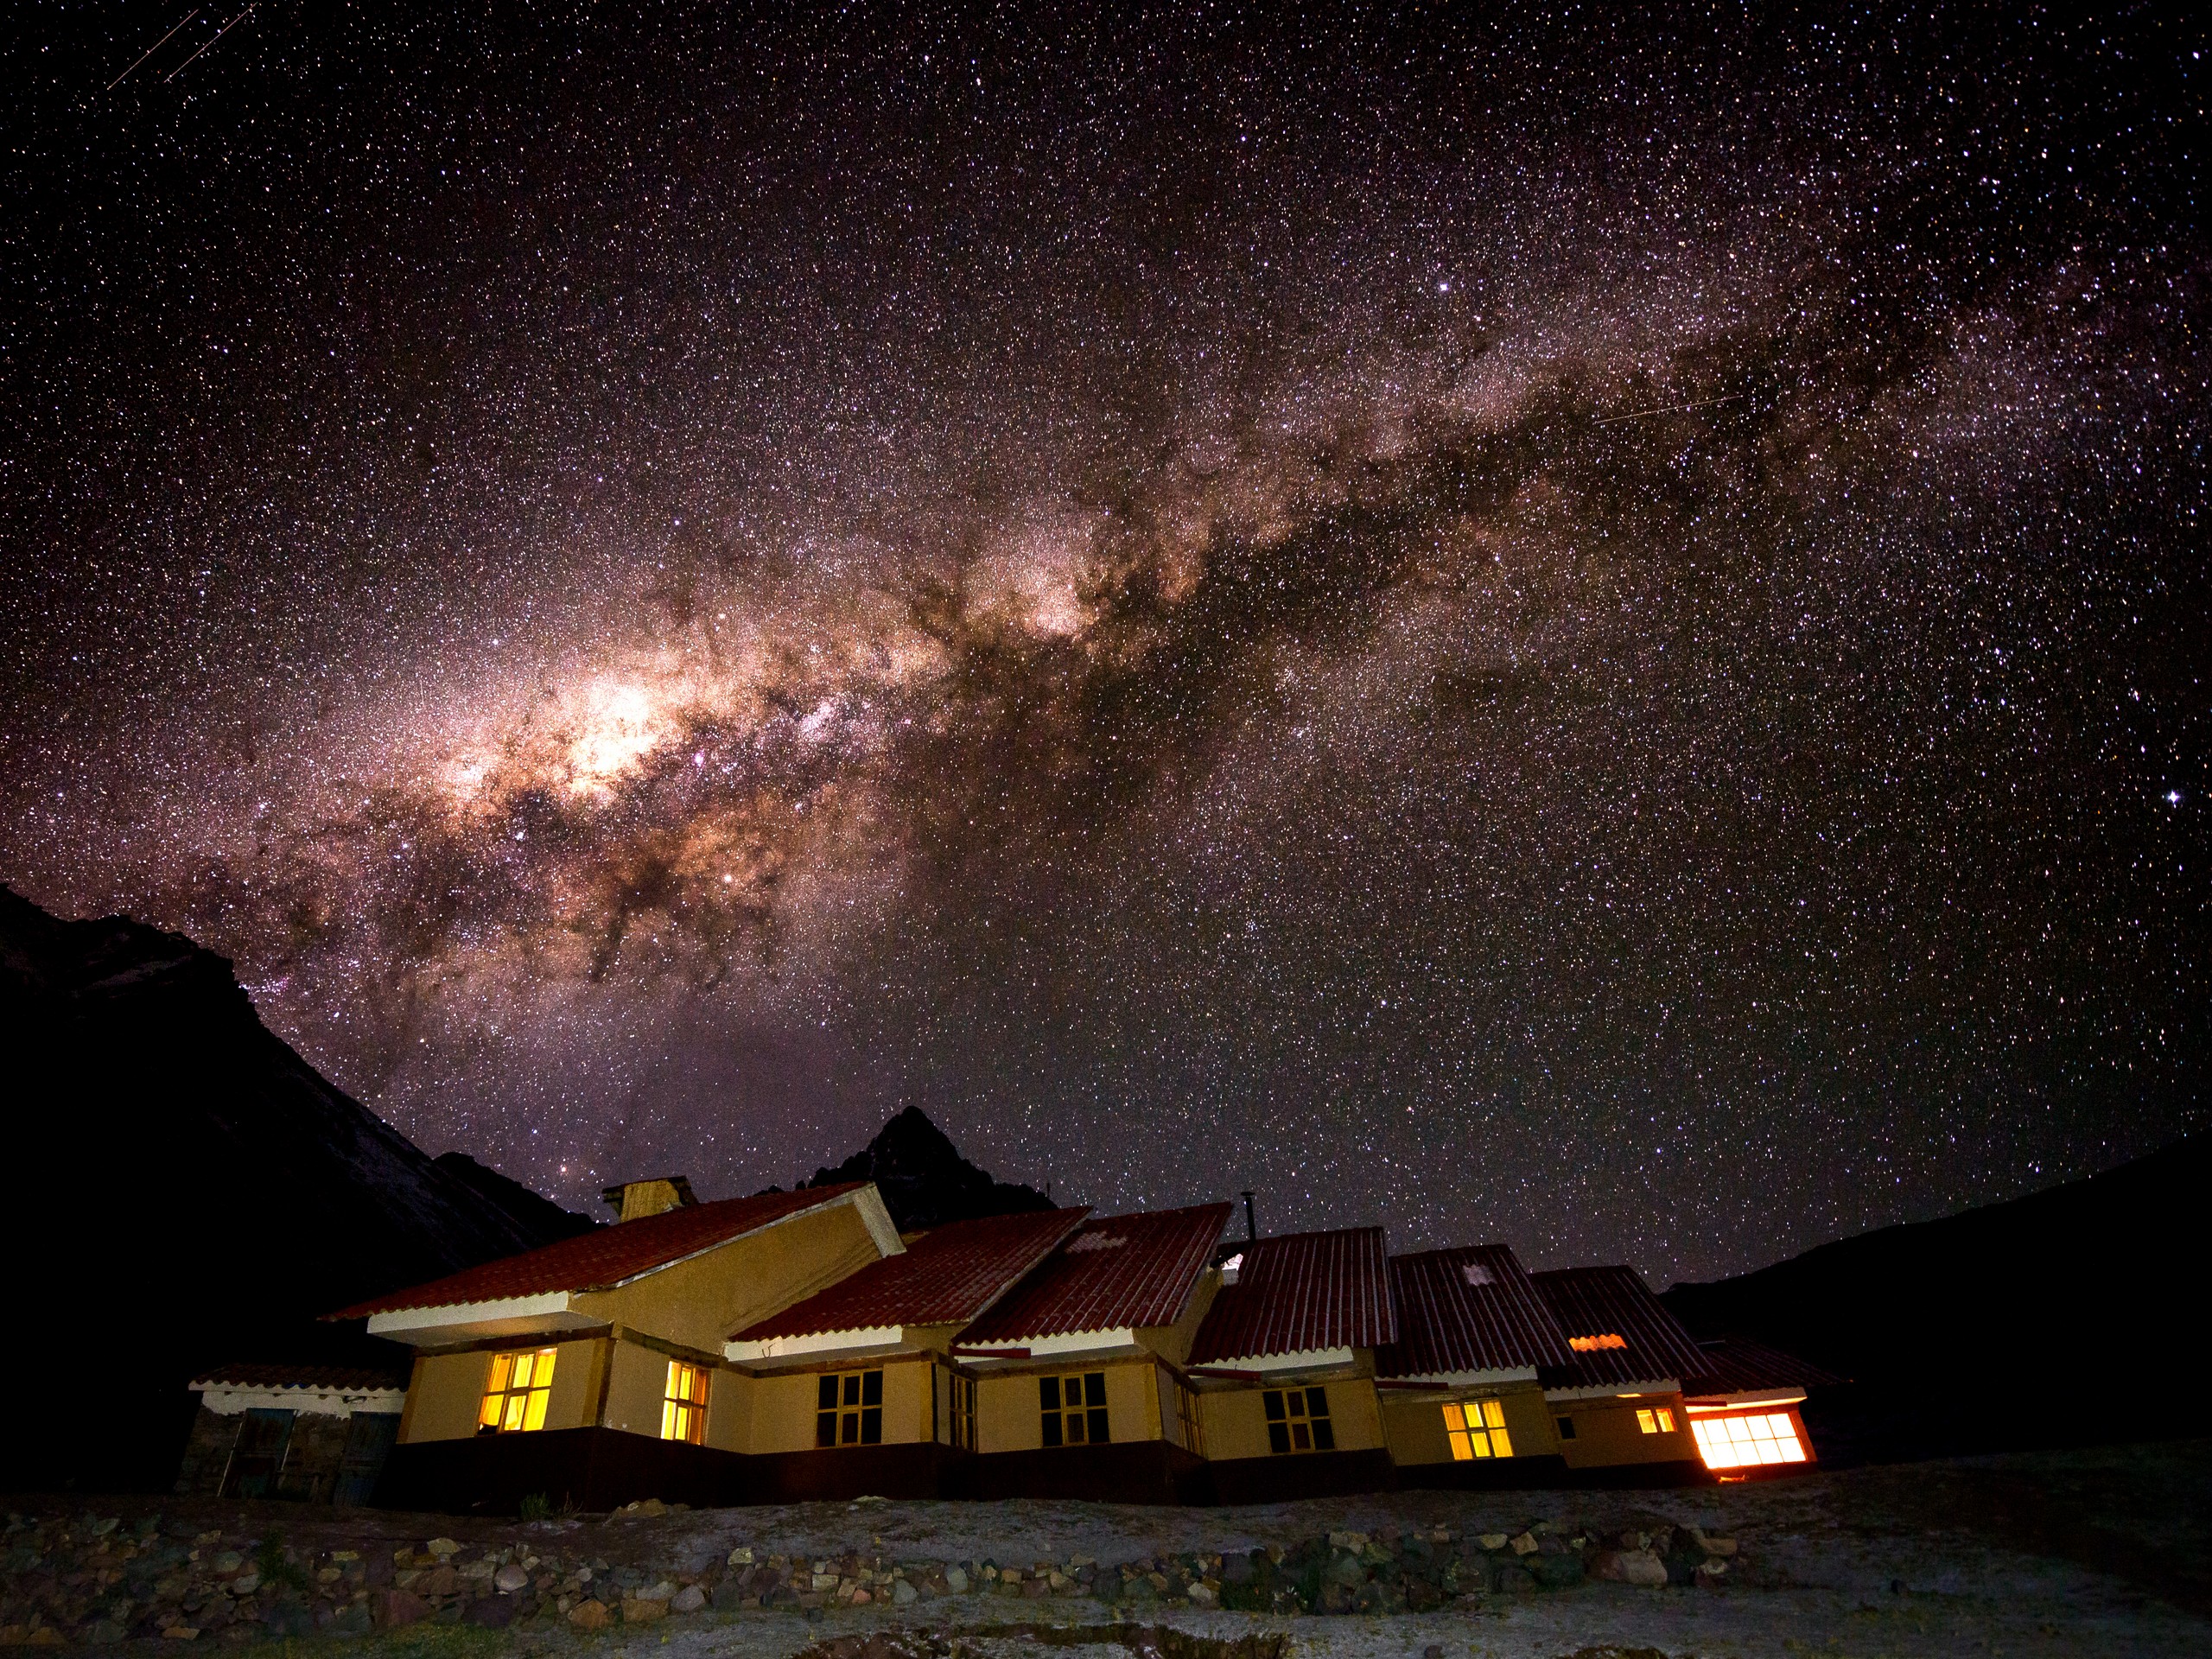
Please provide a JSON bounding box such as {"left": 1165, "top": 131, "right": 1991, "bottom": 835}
{"left": 573, "top": 1204, "right": 878, "bottom": 1354}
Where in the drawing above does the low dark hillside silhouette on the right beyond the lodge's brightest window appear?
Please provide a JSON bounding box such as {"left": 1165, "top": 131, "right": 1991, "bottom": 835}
{"left": 1662, "top": 1137, "right": 2212, "bottom": 1462}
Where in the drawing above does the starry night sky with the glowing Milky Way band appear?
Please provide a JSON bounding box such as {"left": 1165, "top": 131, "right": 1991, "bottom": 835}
{"left": 0, "top": 0, "right": 2212, "bottom": 1283}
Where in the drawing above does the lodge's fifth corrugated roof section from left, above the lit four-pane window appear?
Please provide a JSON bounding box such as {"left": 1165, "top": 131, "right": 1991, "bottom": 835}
{"left": 1376, "top": 1245, "right": 1573, "bottom": 1378}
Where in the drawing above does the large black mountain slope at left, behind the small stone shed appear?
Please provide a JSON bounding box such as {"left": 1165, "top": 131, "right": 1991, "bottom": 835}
{"left": 0, "top": 887, "right": 593, "bottom": 1489}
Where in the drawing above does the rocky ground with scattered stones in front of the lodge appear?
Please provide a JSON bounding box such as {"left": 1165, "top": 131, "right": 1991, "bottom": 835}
{"left": 0, "top": 1442, "right": 2212, "bottom": 1659}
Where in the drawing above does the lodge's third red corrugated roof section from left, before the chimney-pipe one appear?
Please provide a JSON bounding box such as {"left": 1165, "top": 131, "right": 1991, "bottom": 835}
{"left": 960, "top": 1204, "right": 1230, "bottom": 1343}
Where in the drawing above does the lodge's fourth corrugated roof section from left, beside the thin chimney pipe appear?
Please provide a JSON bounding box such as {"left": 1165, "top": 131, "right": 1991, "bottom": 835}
{"left": 1190, "top": 1228, "right": 1398, "bottom": 1365}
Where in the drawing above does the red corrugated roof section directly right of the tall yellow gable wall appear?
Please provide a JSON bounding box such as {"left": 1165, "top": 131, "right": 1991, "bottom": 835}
{"left": 736, "top": 1208, "right": 1090, "bottom": 1343}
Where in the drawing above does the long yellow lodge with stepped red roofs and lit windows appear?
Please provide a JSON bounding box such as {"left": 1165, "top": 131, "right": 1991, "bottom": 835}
{"left": 186, "top": 1177, "right": 1829, "bottom": 1513}
